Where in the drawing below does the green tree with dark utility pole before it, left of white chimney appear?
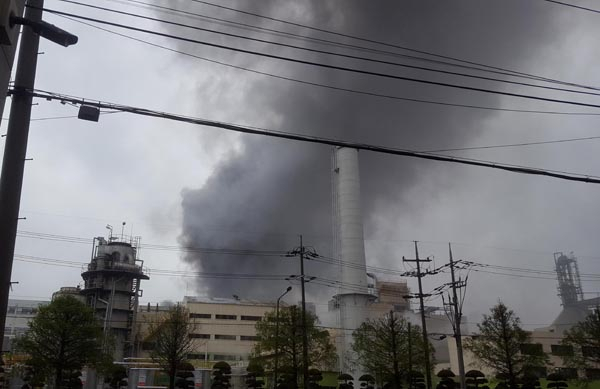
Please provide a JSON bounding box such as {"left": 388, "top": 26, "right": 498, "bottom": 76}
{"left": 253, "top": 306, "right": 336, "bottom": 383}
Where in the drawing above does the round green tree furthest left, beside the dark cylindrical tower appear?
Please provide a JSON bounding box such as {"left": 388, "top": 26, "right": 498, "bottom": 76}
{"left": 15, "top": 296, "right": 110, "bottom": 388}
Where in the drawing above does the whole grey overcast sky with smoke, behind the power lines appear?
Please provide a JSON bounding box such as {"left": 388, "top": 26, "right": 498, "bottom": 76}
{"left": 0, "top": 0, "right": 600, "bottom": 327}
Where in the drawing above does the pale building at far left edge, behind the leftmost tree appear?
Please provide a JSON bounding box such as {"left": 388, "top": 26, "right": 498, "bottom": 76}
{"left": 2, "top": 299, "right": 50, "bottom": 353}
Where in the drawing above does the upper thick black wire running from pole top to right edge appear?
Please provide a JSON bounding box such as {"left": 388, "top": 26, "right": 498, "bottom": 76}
{"left": 36, "top": 8, "right": 600, "bottom": 108}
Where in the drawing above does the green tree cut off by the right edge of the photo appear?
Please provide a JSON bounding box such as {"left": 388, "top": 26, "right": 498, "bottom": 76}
{"left": 561, "top": 307, "right": 600, "bottom": 369}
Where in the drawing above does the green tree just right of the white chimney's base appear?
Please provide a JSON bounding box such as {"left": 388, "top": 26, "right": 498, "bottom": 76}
{"left": 352, "top": 311, "right": 434, "bottom": 388}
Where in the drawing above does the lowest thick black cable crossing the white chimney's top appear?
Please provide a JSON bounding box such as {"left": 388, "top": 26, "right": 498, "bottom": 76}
{"left": 17, "top": 90, "right": 600, "bottom": 184}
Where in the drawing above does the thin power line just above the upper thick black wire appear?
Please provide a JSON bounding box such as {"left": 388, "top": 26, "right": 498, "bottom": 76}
{"left": 48, "top": 0, "right": 600, "bottom": 96}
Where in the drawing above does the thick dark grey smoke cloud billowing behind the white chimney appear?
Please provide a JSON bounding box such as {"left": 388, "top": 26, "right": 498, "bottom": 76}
{"left": 154, "top": 0, "right": 576, "bottom": 310}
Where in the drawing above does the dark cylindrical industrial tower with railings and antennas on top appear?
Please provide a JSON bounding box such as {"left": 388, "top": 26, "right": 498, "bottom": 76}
{"left": 81, "top": 230, "right": 149, "bottom": 361}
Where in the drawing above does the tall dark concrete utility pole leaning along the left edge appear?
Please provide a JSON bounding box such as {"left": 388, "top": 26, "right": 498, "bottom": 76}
{"left": 0, "top": 0, "right": 44, "bottom": 348}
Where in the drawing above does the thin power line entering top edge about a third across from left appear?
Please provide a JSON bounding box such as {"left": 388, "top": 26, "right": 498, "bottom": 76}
{"left": 186, "top": 0, "right": 595, "bottom": 89}
